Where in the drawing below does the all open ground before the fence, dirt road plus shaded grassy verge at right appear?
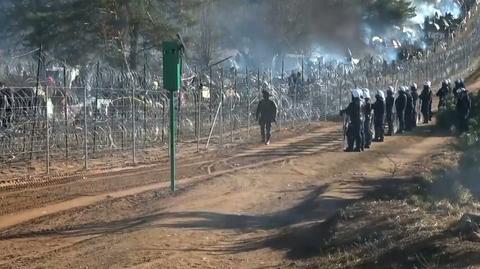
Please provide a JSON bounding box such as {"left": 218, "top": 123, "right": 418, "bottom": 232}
{"left": 0, "top": 87, "right": 480, "bottom": 268}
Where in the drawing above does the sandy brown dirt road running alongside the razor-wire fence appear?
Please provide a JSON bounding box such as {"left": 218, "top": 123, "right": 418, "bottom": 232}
{"left": 0, "top": 120, "right": 453, "bottom": 268}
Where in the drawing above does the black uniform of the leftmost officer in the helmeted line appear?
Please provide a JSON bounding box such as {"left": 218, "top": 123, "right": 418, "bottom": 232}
{"left": 341, "top": 98, "right": 362, "bottom": 152}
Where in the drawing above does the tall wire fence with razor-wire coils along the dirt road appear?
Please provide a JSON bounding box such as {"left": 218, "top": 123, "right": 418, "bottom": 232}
{"left": 0, "top": 5, "right": 480, "bottom": 179}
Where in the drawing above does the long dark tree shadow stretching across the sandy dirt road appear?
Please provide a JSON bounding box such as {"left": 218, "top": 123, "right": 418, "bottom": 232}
{"left": 0, "top": 178, "right": 428, "bottom": 259}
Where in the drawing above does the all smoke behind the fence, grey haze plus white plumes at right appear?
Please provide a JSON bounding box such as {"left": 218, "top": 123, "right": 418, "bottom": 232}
{"left": 202, "top": 0, "right": 461, "bottom": 68}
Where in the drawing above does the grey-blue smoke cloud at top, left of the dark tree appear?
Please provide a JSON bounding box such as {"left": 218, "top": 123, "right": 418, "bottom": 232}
{"left": 202, "top": 0, "right": 366, "bottom": 67}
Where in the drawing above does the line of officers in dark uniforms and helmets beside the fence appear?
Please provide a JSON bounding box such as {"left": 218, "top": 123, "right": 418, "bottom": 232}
{"left": 341, "top": 80, "right": 471, "bottom": 152}
